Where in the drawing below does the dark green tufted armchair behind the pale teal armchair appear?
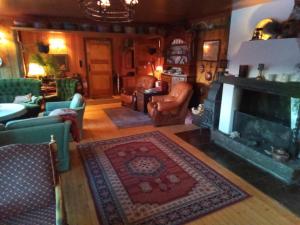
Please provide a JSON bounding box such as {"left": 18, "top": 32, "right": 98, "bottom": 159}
{"left": 46, "top": 78, "right": 78, "bottom": 102}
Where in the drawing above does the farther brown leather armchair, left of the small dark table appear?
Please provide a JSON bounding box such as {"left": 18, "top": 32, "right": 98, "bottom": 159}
{"left": 121, "top": 75, "right": 157, "bottom": 110}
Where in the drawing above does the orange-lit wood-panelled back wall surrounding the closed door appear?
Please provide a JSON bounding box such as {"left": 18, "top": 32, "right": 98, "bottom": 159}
{"left": 18, "top": 29, "right": 163, "bottom": 96}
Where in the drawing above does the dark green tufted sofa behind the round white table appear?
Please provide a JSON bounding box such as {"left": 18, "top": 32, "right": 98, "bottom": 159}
{"left": 0, "top": 78, "right": 42, "bottom": 117}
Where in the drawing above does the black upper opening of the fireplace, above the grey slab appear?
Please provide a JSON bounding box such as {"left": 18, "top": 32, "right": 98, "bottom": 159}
{"left": 239, "top": 89, "right": 291, "bottom": 127}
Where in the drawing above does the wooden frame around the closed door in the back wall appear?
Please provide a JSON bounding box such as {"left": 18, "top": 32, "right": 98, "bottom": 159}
{"left": 83, "top": 38, "right": 115, "bottom": 97}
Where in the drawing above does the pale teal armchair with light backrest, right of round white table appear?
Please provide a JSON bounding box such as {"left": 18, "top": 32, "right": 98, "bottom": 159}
{"left": 44, "top": 93, "right": 85, "bottom": 137}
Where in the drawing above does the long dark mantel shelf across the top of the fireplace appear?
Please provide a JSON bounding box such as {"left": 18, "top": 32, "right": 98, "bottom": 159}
{"left": 219, "top": 76, "right": 300, "bottom": 98}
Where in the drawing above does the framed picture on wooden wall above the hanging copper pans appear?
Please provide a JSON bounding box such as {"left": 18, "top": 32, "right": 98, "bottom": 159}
{"left": 202, "top": 40, "right": 220, "bottom": 62}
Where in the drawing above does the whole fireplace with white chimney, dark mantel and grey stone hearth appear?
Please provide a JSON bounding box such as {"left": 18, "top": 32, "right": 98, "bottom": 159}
{"left": 212, "top": 0, "right": 300, "bottom": 183}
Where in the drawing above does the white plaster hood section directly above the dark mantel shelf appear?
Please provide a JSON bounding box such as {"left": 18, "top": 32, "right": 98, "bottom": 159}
{"left": 235, "top": 38, "right": 300, "bottom": 77}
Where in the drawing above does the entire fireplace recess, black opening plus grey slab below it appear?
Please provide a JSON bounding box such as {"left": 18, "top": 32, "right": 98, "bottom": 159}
{"left": 233, "top": 89, "right": 292, "bottom": 151}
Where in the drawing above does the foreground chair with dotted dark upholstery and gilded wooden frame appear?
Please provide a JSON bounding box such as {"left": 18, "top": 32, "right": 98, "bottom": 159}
{"left": 0, "top": 144, "right": 66, "bottom": 225}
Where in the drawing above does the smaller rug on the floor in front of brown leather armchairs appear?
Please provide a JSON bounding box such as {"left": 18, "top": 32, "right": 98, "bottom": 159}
{"left": 103, "top": 107, "right": 152, "bottom": 128}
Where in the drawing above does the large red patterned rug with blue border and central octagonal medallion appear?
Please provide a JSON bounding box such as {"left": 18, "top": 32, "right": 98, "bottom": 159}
{"left": 78, "top": 131, "right": 249, "bottom": 225}
